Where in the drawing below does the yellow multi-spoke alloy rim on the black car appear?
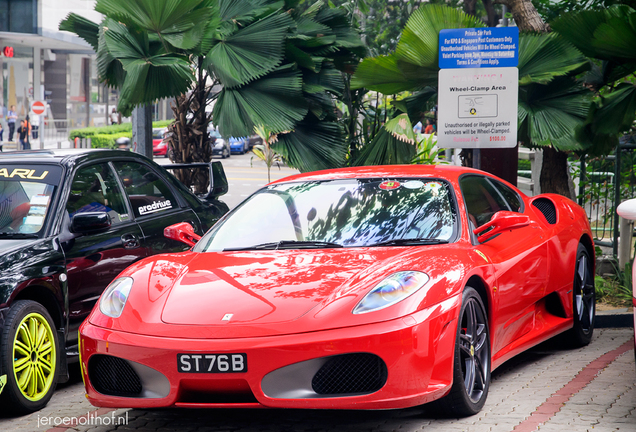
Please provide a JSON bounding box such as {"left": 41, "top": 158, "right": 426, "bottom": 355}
{"left": 13, "top": 312, "right": 57, "bottom": 402}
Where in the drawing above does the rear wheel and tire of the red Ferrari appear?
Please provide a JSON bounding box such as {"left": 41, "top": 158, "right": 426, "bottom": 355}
{"left": 566, "top": 244, "right": 596, "bottom": 347}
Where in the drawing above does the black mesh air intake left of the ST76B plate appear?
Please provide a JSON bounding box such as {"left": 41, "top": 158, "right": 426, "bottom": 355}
{"left": 88, "top": 354, "right": 142, "bottom": 397}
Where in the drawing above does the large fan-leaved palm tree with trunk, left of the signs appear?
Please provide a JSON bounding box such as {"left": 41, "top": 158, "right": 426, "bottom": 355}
{"left": 60, "top": 0, "right": 365, "bottom": 176}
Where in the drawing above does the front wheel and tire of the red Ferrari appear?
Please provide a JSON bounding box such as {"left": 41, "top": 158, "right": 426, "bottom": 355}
{"left": 437, "top": 287, "right": 490, "bottom": 417}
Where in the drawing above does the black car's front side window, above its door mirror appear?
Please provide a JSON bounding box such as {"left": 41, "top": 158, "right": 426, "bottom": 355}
{"left": 66, "top": 164, "right": 130, "bottom": 224}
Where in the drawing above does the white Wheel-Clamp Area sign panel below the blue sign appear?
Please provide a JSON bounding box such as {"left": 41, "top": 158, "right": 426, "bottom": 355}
{"left": 437, "top": 67, "right": 519, "bottom": 148}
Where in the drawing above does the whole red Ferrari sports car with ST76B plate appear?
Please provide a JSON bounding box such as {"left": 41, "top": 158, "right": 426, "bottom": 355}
{"left": 80, "top": 165, "right": 595, "bottom": 415}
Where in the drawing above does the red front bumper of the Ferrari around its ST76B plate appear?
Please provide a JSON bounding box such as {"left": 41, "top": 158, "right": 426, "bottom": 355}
{"left": 80, "top": 297, "right": 461, "bottom": 409}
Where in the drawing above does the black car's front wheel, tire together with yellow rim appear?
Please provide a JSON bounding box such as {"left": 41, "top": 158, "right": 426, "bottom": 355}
{"left": 0, "top": 300, "right": 62, "bottom": 414}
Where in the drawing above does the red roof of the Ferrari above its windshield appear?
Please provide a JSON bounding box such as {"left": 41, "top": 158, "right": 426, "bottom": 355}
{"left": 272, "top": 165, "right": 492, "bottom": 183}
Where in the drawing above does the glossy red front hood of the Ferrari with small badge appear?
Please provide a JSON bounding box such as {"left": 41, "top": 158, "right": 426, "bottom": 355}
{"left": 161, "top": 250, "right": 380, "bottom": 325}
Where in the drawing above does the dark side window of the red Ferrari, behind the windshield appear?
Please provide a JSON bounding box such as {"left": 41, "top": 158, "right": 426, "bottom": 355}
{"left": 459, "top": 176, "right": 510, "bottom": 227}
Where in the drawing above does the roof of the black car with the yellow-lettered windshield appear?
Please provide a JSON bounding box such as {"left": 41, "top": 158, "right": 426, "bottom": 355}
{"left": 0, "top": 148, "right": 149, "bottom": 166}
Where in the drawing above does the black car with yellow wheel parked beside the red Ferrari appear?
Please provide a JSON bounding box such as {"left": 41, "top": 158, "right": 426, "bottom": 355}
{"left": 0, "top": 150, "right": 228, "bottom": 413}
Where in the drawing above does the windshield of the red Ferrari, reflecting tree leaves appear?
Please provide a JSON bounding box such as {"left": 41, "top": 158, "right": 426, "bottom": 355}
{"left": 195, "top": 178, "right": 456, "bottom": 252}
